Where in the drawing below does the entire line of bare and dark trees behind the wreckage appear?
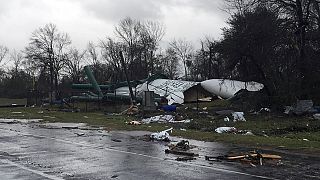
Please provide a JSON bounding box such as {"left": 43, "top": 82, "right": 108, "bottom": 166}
{"left": 0, "top": 0, "right": 320, "bottom": 102}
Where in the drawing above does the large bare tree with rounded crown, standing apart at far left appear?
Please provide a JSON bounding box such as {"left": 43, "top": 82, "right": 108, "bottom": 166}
{"left": 25, "top": 24, "right": 71, "bottom": 101}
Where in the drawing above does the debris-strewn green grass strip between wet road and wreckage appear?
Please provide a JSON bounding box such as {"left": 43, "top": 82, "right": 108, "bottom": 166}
{"left": 0, "top": 105, "right": 320, "bottom": 153}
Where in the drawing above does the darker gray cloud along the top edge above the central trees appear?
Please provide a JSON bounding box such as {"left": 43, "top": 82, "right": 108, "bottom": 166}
{"left": 82, "top": 0, "right": 226, "bottom": 21}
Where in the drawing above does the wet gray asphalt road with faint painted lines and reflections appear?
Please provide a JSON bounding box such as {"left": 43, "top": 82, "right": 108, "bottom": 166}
{"left": 0, "top": 123, "right": 318, "bottom": 180}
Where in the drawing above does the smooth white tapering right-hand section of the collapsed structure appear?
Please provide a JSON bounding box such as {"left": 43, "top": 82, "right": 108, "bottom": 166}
{"left": 201, "top": 79, "right": 264, "bottom": 99}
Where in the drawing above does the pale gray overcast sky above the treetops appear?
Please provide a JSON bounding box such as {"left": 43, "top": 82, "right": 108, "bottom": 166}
{"left": 0, "top": 0, "right": 228, "bottom": 50}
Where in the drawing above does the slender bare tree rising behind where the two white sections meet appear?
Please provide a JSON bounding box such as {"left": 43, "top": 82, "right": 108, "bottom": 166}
{"left": 170, "top": 39, "right": 193, "bottom": 79}
